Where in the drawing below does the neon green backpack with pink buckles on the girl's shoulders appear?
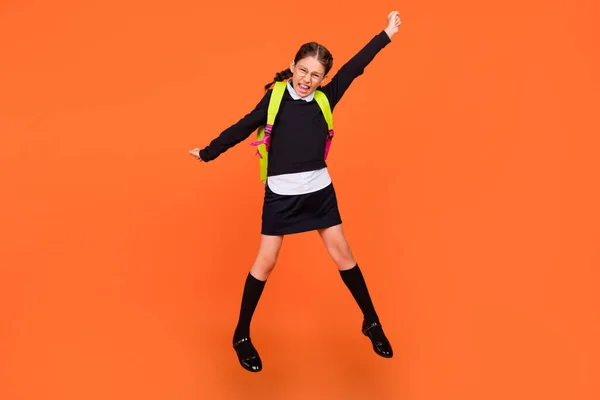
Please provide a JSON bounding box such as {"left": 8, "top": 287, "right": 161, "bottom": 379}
{"left": 251, "top": 82, "right": 333, "bottom": 184}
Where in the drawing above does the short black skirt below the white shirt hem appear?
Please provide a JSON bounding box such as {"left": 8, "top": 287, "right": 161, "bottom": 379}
{"left": 261, "top": 184, "right": 342, "bottom": 236}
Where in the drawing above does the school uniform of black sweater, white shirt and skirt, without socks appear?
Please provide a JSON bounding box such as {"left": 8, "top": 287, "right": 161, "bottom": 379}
{"left": 200, "top": 31, "right": 391, "bottom": 235}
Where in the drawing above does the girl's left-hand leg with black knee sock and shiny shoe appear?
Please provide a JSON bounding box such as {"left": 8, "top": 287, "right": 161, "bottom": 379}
{"left": 233, "top": 235, "right": 283, "bottom": 372}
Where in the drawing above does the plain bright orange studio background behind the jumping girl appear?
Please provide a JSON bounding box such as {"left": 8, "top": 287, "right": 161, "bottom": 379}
{"left": 0, "top": 0, "right": 600, "bottom": 400}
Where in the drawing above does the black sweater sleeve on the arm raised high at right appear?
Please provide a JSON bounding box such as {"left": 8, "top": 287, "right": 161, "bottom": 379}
{"left": 321, "top": 31, "right": 391, "bottom": 111}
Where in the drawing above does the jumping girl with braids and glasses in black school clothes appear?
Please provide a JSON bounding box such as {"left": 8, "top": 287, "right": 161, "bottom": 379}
{"left": 189, "top": 11, "right": 401, "bottom": 372}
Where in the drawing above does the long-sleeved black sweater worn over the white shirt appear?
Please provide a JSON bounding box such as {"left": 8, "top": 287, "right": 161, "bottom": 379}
{"left": 200, "top": 31, "right": 390, "bottom": 176}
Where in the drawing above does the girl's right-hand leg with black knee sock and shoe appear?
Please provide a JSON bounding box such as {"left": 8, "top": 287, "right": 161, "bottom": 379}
{"left": 319, "top": 225, "right": 393, "bottom": 358}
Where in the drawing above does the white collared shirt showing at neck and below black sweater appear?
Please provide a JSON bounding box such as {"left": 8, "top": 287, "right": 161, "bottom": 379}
{"left": 267, "top": 79, "right": 331, "bottom": 195}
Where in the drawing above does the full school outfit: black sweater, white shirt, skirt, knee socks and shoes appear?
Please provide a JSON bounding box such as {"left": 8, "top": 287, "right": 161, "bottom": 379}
{"left": 200, "top": 31, "right": 393, "bottom": 372}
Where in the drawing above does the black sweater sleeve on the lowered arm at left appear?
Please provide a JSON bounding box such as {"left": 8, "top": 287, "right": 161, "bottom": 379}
{"left": 200, "top": 89, "right": 273, "bottom": 162}
